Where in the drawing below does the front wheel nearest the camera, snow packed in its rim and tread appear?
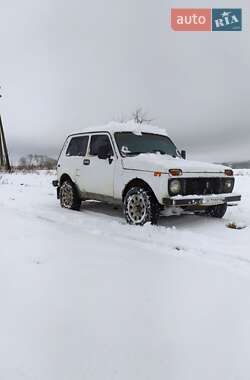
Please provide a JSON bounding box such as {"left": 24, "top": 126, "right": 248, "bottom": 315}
{"left": 123, "top": 187, "right": 160, "bottom": 226}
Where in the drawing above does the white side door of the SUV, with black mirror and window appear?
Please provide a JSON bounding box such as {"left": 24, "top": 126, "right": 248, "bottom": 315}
{"left": 79, "top": 133, "right": 116, "bottom": 197}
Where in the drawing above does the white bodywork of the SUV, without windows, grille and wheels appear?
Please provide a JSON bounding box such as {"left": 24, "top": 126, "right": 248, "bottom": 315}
{"left": 57, "top": 122, "right": 240, "bottom": 211}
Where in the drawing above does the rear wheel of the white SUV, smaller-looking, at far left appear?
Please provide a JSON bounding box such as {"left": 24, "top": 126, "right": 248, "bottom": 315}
{"left": 59, "top": 180, "right": 81, "bottom": 211}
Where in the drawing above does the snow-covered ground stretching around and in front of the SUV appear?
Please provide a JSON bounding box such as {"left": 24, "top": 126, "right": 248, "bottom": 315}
{"left": 0, "top": 171, "right": 250, "bottom": 380}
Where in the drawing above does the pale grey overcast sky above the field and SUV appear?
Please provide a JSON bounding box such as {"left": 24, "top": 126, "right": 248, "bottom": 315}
{"left": 0, "top": 0, "right": 250, "bottom": 161}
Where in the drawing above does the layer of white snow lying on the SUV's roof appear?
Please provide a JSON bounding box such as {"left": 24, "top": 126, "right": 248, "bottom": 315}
{"left": 70, "top": 121, "right": 168, "bottom": 136}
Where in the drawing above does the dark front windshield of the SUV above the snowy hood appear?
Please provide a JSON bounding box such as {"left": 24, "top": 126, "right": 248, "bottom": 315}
{"left": 115, "top": 132, "right": 180, "bottom": 157}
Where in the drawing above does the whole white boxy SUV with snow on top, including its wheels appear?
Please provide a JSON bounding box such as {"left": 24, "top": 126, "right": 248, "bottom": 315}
{"left": 53, "top": 122, "right": 241, "bottom": 225}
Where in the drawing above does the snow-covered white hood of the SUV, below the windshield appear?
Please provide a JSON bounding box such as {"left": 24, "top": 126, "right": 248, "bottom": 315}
{"left": 122, "top": 153, "right": 230, "bottom": 173}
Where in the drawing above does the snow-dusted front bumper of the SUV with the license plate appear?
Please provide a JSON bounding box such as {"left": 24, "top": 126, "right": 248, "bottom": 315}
{"left": 163, "top": 193, "right": 241, "bottom": 207}
